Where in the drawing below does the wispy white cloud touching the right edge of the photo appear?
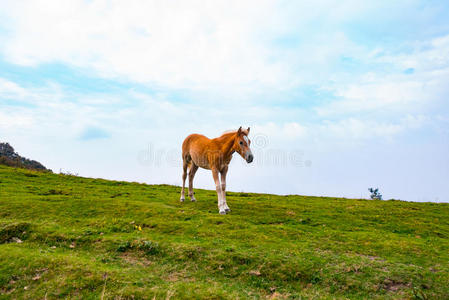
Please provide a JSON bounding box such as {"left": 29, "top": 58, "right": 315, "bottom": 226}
{"left": 316, "top": 35, "right": 449, "bottom": 118}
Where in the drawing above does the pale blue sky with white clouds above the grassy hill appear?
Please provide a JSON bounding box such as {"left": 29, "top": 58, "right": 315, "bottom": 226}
{"left": 0, "top": 0, "right": 449, "bottom": 202}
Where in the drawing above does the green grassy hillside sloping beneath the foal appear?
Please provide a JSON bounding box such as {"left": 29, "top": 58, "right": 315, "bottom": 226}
{"left": 0, "top": 166, "right": 449, "bottom": 299}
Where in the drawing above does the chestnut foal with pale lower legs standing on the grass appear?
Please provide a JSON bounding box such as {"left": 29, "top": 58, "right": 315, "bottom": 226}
{"left": 180, "top": 126, "right": 254, "bottom": 215}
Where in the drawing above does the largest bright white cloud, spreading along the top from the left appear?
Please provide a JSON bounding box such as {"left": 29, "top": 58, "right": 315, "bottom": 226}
{"left": 1, "top": 0, "right": 406, "bottom": 98}
